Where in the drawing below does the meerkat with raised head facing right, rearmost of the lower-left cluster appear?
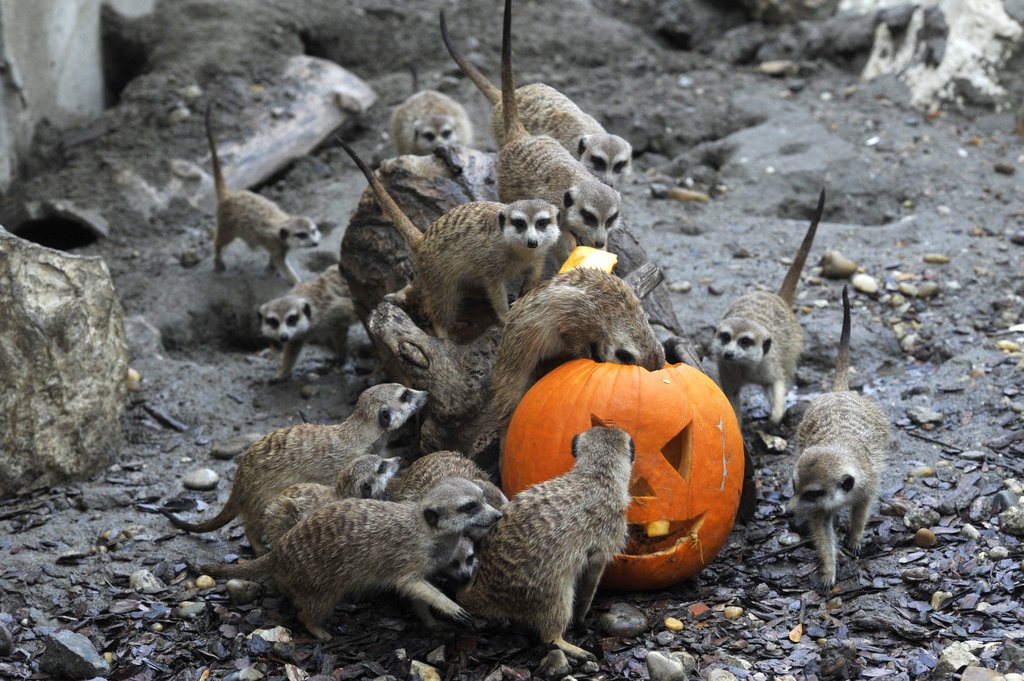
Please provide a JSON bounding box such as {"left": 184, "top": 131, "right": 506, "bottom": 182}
{"left": 165, "top": 383, "right": 427, "bottom": 555}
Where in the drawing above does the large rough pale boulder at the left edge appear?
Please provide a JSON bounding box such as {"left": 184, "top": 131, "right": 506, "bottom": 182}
{"left": 0, "top": 227, "right": 128, "bottom": 497}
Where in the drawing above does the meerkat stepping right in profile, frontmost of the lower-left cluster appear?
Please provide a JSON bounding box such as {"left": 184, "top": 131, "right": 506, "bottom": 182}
{"left": 202, "top": 479, "right": 502, "bottom": 640}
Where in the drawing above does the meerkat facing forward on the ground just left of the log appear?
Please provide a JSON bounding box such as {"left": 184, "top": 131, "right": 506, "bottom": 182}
{"left": 257, "top": 265, "right": 357, "bottom": 382}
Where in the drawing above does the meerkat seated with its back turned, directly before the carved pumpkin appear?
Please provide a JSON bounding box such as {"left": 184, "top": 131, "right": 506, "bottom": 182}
{"left": 456, "top": 426, "right": 634, "bottom": 658}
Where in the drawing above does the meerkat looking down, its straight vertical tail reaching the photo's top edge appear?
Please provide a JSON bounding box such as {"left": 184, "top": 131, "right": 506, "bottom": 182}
{"left": 498, "top": 0, "right": 622, "bottom": 255}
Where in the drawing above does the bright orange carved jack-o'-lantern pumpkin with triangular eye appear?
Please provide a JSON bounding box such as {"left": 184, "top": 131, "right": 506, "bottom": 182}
{"left": 502, "top": 359, "right": 743, "bottom": 590}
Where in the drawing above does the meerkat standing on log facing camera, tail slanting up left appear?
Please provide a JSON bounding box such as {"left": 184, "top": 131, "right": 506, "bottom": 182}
{"left": 341, "top": 141, "right": 559, "bottom": 338}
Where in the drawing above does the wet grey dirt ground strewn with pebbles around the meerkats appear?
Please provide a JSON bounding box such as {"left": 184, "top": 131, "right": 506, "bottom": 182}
{"left": 0, "top": 0, "right": 1024, "bottom": 680}
